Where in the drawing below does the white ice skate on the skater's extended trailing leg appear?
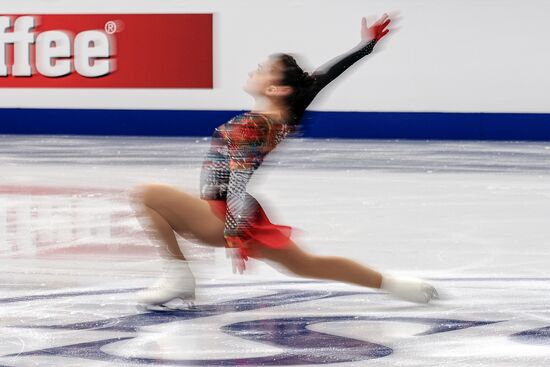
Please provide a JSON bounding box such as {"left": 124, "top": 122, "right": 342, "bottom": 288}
{"left": 380, "top": 275, "right": 439, "bottom": 303}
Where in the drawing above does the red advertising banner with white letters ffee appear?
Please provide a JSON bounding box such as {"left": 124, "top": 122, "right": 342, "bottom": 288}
{"left": 0, "top": 14, "right": 213, "bottom": 88}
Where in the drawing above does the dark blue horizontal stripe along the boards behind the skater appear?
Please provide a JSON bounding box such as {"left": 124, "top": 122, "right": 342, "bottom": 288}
{"left": 0, "top": 108, "right": 550, "bottom": 141}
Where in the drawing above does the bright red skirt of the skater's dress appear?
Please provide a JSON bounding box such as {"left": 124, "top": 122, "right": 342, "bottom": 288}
{"left": 206, "top": 200, "right": 292, "bottom": 260}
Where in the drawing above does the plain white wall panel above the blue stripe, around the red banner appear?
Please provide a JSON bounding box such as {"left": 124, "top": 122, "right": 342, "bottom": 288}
{"left": 0, "top": 0, "right": 550, "bottom": 113}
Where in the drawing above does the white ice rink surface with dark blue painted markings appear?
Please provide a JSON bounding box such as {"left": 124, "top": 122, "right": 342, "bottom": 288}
{"left": 0, "top": 136, "right": 550, "bottom": 367}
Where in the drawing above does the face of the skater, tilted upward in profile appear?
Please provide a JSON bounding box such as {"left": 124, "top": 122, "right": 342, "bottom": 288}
{"left": 244, "top": 58, "right": 291, "bottom": 99}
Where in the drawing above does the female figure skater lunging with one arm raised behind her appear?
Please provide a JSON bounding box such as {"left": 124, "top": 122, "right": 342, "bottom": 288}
{"left": 134, "top": 14, "right": 437, "bottom": 306}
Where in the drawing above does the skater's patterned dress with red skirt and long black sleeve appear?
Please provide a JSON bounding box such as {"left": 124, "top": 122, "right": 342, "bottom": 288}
{"left": 201, "top": 41, "right": 376, "bottom": 259}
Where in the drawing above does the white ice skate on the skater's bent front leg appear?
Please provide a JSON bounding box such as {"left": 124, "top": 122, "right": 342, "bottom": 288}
{"left": 136, "top": 260, "right": 195, "bottom": 310}
